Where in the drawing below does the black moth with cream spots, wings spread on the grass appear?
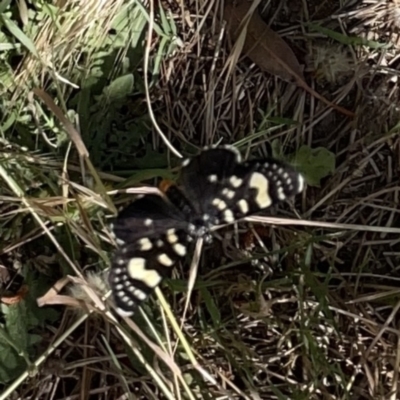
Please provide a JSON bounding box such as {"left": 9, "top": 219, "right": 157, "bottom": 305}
{"left": 109, "top": 146, "right": 304, "bottom": 316}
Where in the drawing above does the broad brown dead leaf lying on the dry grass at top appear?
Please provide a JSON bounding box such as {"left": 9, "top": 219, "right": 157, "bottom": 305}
{"left": 224, "top": 0, "right": 304, "bottom": 82}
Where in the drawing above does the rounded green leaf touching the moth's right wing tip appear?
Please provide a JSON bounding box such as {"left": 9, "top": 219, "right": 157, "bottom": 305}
{"left": 290, "top": 146, "right": 336, "bottom": 187}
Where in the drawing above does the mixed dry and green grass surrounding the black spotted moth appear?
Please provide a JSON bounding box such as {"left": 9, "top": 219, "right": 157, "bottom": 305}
{"left": 0, "top": 0, "right": 400, "bottom": 400}
